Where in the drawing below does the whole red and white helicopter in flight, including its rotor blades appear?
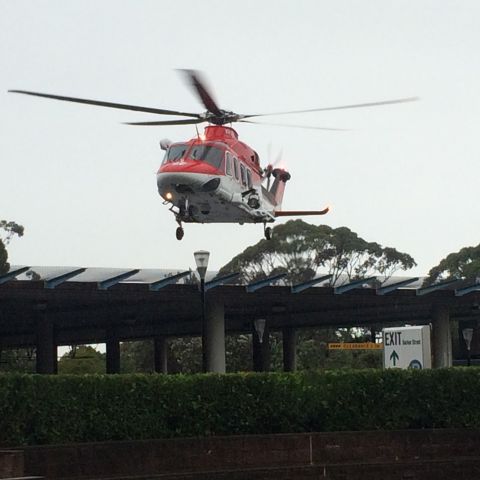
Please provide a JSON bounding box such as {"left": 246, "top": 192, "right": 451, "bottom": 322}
{"left": 9, "top": 70, "right": 417, "bottom": 240}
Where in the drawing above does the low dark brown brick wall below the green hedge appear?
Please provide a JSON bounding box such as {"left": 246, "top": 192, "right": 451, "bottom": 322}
{"left": 23, "top": 430, "right": 480, "bottom": 480}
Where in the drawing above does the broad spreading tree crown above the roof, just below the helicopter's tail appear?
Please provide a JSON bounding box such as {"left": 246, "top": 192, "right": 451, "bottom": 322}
{"left": 219, "top": 220, "right": 416, "bottom": 285}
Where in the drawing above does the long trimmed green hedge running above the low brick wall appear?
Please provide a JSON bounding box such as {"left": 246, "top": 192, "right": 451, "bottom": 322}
{"left": 0, "top": 367, "right": 480, "bottom": 446}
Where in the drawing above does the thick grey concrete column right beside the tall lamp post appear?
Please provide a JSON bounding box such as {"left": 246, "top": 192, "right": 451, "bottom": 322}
{"left": 205, "top": 295, "right": 225, "bottom": 373}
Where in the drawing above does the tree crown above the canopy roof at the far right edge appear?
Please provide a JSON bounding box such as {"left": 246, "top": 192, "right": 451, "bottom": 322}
{"left": 426, "top": 244, "right": 480, "bottom": 284}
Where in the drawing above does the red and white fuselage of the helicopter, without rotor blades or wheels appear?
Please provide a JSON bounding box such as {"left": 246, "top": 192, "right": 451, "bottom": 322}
{"left": 157, "top": 125, "right": 289, "bottom": 224}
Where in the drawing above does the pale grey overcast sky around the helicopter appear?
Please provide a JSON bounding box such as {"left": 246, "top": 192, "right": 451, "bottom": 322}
{"left": 0, "top": 0, "right": 480, "bottom": 275}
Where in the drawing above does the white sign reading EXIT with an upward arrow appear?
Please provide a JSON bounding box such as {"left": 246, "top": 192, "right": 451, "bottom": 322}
{"left": 383, "top": 325, "right": 432, "bottom": 368}
